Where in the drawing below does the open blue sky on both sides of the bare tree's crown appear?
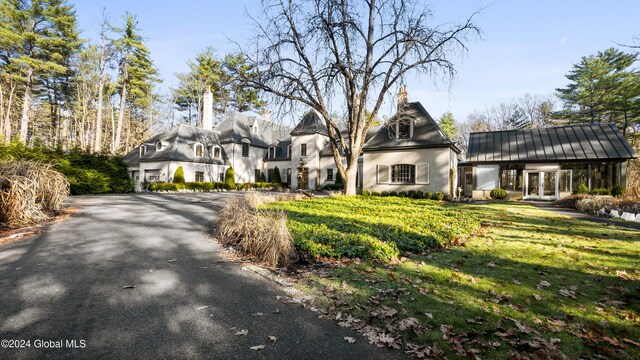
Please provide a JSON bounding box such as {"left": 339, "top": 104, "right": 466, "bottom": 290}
{"left": 72, "top": 0, "right": 640, "bottom": 124}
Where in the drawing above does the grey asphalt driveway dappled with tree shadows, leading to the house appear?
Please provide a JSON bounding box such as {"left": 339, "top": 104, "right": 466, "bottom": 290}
{"left": 0, "top": 193, "right": 403, "bottom": 359}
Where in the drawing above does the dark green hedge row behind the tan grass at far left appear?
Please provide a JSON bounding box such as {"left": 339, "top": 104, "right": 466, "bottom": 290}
{"left": 0, "top": 142, "right": 134, "bottom": 195}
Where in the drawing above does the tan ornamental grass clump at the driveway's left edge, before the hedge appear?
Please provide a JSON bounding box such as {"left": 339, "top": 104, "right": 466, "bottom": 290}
{"left": 0, "top": 161, "right": 69, "bottom": 227}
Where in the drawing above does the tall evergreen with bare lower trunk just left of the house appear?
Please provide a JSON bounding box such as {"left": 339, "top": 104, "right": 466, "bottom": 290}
{"left": 112, "top": 13, "right": 158, "bottom": 152}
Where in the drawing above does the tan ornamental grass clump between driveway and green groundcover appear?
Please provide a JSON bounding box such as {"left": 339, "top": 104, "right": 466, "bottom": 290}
{"left": 218, "top": 193, "right": 296, "bottom": 266}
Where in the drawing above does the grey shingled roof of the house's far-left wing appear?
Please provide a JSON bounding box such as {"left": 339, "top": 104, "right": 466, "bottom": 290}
{"left": 124, "top": 125, "right": 226, "bottom": 165}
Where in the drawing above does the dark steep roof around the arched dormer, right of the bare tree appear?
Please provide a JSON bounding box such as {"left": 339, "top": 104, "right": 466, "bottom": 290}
{"left": 364, "top": 102, "right": 460, "bottom": 152}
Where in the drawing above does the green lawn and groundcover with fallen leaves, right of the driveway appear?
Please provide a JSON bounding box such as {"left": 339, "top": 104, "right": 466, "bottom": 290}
{"left": 270, "top": 197, "right": 640, "bottom": 359}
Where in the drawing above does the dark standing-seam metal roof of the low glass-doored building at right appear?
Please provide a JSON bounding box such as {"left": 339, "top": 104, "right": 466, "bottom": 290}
{"left": 466, "top": 124, "right": 637, "bottom": 163}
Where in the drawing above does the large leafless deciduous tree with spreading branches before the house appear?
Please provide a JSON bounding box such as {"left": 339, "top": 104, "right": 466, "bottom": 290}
{"left": 243, "top": 0, "right": 480, "bottom": 195}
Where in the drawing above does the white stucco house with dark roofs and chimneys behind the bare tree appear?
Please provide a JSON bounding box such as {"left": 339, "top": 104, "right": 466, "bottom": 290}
{"left": 125, "top": 88, "right": 460, "bottom": 194}
